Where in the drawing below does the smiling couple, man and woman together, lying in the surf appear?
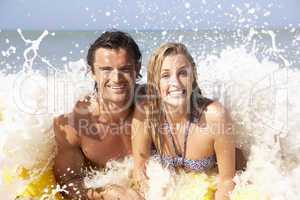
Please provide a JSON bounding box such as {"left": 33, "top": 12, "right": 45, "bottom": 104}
{"left": 54, "top": 31, "right": 243, "bottom": 200}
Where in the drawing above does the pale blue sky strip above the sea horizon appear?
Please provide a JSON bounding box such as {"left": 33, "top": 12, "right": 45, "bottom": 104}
{"left": 0, "top": 0, "right": 300, "bottom": 30}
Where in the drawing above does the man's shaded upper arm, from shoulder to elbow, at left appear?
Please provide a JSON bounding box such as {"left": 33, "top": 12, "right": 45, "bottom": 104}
{"left": 53, "top": 116, "right": 97, "bottom": 200}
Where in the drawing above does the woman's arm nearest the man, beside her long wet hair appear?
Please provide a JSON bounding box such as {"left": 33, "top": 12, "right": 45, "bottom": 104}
{"left": 131, "top": 104, "right": 152, "bottom": 191}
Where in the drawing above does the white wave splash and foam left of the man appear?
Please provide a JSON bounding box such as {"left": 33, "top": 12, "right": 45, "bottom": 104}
{"left": 0, "top": 30, "right": 92, "bottom": 199}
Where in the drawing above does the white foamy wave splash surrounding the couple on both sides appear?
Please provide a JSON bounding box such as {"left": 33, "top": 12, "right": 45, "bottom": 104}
{"left": 0, "top": 27, "right": 300, "bottom": 200}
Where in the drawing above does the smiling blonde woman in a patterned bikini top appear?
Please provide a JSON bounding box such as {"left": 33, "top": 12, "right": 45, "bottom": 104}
{"left": 132, "top": 43, "right": 236, "bottom": 200}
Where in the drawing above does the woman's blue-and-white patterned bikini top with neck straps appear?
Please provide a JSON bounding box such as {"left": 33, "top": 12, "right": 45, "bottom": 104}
{"left": 154, "top": 97, "right": 217, "bottom": 172}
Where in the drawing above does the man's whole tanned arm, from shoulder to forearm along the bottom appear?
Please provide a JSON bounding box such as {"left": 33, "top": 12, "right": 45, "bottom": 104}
{"left": 54, "top": 116, "right": 142, "bottom": 200}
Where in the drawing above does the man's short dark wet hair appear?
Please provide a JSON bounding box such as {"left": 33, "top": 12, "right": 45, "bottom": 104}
{"left": 87, "top": 31, "right": 142, "bottom": 77}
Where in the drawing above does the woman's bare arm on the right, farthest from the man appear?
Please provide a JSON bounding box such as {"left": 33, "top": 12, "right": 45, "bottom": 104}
{"left": 207, "top": 102, "right": 236, "bottom": 200}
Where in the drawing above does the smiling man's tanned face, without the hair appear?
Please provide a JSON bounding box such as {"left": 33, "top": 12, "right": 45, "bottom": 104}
{"left": 93, "top": 48, "right": 136, "bottom": 106}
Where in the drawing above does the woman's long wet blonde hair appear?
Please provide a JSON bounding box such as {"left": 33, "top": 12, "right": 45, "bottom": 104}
{"left": 146, "top": 43, "right": 206, "bottom": 155}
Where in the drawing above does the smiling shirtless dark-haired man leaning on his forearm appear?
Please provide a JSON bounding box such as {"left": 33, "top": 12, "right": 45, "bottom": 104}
{"left": 54, "top": 31, "right": 145, "bottom": 200}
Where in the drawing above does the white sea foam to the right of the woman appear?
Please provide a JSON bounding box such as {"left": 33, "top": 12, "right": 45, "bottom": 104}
{"left": 200, "top": 47, "right": 300, "bottom": 199}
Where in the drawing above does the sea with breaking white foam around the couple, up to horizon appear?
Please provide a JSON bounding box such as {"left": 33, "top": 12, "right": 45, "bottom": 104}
{"left": 0, "top": 28, "right": 300, "bottom": 200}
